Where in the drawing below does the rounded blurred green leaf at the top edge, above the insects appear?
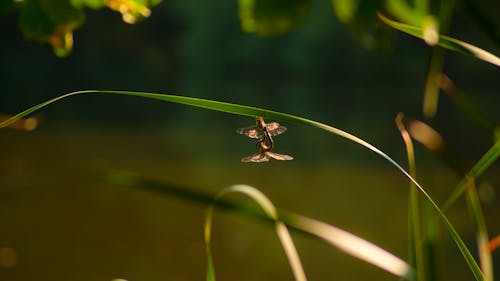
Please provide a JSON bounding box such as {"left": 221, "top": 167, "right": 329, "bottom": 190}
{"left": 238, "top": 0, "right": 311, "bottom": 35}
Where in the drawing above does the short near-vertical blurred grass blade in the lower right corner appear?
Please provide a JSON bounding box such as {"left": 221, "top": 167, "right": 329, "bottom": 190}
{"left": 466, "top": 177, "right": 494, "bottom": 281}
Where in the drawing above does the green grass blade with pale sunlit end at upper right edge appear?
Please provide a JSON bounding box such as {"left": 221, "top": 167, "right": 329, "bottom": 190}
{"left": 378, "top": 13, "right": 500, "bottom": 66}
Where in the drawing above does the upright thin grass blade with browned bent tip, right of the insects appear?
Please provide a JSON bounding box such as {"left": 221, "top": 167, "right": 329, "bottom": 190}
{"left": 395, "top": 113, "right": 425, "bottom": 281}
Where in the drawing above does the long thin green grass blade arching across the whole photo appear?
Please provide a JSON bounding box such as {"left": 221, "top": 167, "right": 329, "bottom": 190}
{"left": 0, "top": 90, "right": 484, "bottom": 280}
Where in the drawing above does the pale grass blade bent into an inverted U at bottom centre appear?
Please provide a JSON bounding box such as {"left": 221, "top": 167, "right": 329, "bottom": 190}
{"left": 205, "top": 185, "right": 307, "bottom": 281}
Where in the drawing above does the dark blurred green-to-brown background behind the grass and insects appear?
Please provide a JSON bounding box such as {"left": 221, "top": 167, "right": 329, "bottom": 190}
{"left": 0, "top": 0, "right": 500, "bottom": 281}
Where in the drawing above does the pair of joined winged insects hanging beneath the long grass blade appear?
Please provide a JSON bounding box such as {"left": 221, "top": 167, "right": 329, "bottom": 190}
{"left": 236, "top": 117, "right": 293, "bottom": 162}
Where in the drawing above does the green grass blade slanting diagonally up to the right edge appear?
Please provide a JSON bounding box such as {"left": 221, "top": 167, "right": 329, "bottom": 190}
{"left": 442, "top": 139, "right": 500, "bottom": 210}
